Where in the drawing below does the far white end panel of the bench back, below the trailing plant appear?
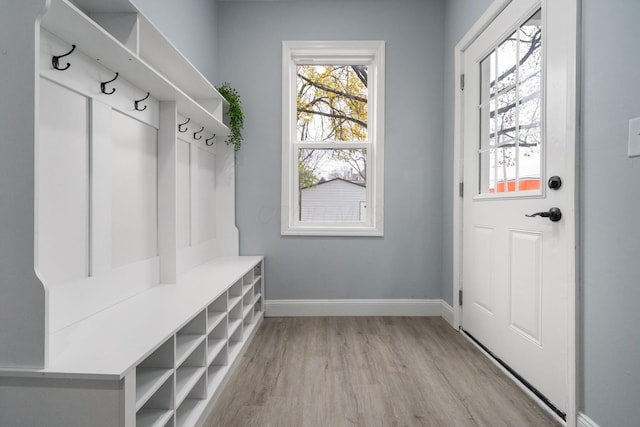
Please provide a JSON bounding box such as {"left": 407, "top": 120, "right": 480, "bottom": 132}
{"left": 216, "top": 142, "right": 240, "bottom": 256}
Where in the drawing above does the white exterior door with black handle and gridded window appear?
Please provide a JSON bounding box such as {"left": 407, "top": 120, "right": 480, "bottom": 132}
{"left": 462, "top": 0, "right": 575, "bottom": 413}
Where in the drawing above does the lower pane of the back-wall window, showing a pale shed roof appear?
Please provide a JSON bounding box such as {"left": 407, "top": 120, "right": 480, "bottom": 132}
{"left": 298, "top": 149, "right": 367, "bottom": 222}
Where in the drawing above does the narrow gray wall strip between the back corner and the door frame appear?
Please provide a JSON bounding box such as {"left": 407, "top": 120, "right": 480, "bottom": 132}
{"left": 441, "top": 0, "right": 492, "bottom": 305}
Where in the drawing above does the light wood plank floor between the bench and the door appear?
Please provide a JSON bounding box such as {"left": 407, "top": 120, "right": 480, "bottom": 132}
{"left": 205, "top": 317, "right": 557, "bottom": 427}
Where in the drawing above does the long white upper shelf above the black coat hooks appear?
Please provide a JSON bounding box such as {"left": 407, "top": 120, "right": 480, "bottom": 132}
{"left": 41, "top": 0, "right": 229, "bottom": 136}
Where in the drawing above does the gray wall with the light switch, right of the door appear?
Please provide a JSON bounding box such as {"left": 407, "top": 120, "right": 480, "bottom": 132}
{"left": 580, "top": 0, "right": 640, "bottom": 427}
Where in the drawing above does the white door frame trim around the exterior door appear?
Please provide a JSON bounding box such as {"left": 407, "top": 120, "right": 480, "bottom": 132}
{"left": 452, "top": 0, "right": 580, "bottom": 427}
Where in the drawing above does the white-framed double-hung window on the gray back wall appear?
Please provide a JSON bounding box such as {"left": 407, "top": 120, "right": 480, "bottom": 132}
{"left": 282, "top": 41, "right": 384, "bottom": 236}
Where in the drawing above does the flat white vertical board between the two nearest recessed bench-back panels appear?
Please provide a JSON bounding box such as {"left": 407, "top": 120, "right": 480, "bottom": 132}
{"left": 89, "top": 99, "right": 113, "bottom": 276}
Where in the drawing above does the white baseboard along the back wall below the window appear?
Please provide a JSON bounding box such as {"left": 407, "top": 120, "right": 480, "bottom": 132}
{"left": 264, "top": 299, "right": 444, "bottom": 321}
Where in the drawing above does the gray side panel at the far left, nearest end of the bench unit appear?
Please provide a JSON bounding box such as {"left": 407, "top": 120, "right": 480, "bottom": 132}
{"left": 0, "top": 0, "right": 49, "bottom": 368}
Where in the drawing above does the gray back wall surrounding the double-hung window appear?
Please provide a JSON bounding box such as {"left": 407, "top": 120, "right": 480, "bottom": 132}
{"left": 217, "top": 0, "right": 444, "bottom": 299}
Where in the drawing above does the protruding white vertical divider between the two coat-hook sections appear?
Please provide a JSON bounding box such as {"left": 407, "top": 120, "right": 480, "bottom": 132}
{"left": 158, "top": 101, "right": 178, "bottom": 283}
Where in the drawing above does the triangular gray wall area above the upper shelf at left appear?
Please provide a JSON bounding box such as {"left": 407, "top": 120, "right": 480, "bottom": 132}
{"left": 131, "top": 0, "right": 218, "bottom": 84}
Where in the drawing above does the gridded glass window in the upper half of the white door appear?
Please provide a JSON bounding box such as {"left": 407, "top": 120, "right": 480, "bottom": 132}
{"left": 478, "top": 11, "right": 542, "bottom": 194}
